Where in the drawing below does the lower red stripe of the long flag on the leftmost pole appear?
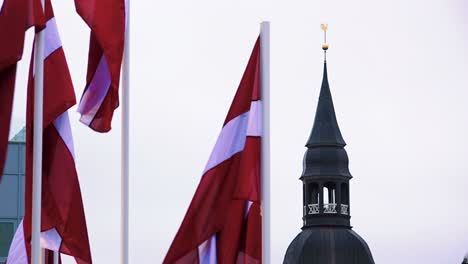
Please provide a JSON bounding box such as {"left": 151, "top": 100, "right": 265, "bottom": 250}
{"left": 42, "top": 125, "right": 91, "bottom": 263}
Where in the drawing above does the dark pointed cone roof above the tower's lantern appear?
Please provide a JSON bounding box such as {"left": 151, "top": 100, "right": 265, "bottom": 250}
{"left": 306, "top": 62, "right": 346, "bottom": 148}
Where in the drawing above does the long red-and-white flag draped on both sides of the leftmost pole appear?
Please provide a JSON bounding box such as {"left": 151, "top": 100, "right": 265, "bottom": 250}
{"left": 8, "top": 0, "right": 92, "bottom": 264}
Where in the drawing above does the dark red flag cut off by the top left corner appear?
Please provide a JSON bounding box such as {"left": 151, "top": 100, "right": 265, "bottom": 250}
{"left": 0, "top": 0, "right": 44, "bottom": 180}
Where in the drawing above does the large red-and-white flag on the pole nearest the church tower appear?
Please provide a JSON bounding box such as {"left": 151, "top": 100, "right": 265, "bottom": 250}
{"left": 164, "top": 38, "right": 262, "bottom": 264}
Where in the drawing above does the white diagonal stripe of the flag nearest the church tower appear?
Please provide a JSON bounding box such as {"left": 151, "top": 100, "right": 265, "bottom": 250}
{"left": 203, "top": 101, "right": 262, "bottom": 174}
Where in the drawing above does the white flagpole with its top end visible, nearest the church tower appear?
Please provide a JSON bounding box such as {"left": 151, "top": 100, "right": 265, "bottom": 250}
{"left": 260, "top": 22, "right": 271, "bottom": 264}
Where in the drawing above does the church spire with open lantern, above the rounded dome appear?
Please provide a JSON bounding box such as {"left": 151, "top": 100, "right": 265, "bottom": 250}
{"left": 301, "top": 25, "right": 352, "bottom": 228}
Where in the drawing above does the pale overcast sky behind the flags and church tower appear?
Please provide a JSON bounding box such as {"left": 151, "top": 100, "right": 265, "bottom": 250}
{"left": 6, "top": 0, "right": 468, "bottom": 264}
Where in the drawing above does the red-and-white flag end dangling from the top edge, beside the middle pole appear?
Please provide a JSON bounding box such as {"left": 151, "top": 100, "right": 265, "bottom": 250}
{"left": 75, "top": 0, "right": 128, "bottom": 132}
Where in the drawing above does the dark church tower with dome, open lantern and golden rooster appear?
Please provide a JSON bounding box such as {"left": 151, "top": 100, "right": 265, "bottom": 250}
{"left": 283, "top": 25, "right": 374, "bottom": 264}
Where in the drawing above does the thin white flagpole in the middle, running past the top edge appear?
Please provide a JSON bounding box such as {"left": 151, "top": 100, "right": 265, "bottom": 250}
{"left": 121, "top": 0, "right": 130, "bottom": 264}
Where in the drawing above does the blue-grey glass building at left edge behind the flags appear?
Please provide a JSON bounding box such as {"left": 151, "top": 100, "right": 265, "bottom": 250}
{"left": 0, "top": 128, "right": 26, "bottom": 264}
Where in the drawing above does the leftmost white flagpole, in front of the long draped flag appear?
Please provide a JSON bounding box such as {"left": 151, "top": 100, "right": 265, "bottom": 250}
{"left": 31, "top": 0, "right": 45, "bottom": 264}
